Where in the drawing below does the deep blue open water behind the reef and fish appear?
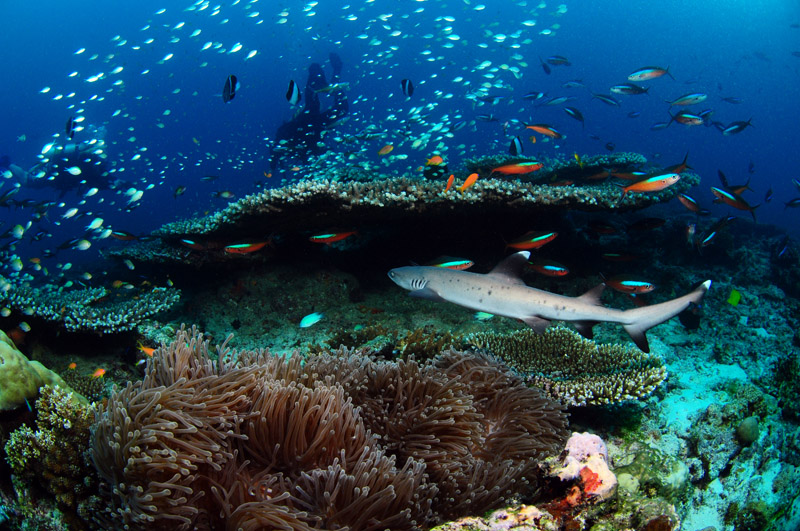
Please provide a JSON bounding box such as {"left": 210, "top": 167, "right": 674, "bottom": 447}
{"left": 0, "top": 0, "right": 800, "bottom": 278}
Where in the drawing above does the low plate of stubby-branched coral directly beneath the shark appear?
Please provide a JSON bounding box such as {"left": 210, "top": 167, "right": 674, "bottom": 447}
{"left": 465, "top": 327, "right": 667, "bottom": 406}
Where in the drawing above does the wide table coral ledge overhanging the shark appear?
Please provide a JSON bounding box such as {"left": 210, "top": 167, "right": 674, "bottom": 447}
{"left": 108, "top": 154, "right": 699, "bottom": 266}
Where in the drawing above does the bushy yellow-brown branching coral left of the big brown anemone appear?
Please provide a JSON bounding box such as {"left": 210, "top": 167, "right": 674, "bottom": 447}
{"left": 5, "top": 385, "right": 97, "bottom": 523}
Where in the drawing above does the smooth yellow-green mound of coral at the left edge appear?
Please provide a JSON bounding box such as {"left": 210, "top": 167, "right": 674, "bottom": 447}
{"left": 0, "top": 331, "right": 86, "bottom": 412}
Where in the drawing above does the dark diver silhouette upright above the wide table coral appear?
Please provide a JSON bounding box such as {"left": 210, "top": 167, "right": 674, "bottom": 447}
{"left": 270, "top": 53, "right": 350, "bottom": 170}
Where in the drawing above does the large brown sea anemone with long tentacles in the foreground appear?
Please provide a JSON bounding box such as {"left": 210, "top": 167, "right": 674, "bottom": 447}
{"left": 92, "top": 329, "right": 568, "bottom": 530}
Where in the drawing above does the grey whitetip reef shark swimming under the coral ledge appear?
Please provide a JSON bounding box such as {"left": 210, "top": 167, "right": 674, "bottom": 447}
{"left": 389, "top": 251, "right": 711, "bottom": 352}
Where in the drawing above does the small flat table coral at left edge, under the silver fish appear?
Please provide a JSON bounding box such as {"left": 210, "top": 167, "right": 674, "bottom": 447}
{"left": 0, "top": 277, "right": 180, "bottom": 333}
